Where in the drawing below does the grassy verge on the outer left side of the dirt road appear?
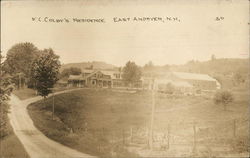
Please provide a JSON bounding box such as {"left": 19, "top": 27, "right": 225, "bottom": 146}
{"left": 0, "top": 104, "right": 29, "bottom": 158}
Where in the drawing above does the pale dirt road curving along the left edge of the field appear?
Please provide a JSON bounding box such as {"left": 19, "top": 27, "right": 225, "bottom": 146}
{"left": 8, "top": 90, "right": 93, "bottom": 158}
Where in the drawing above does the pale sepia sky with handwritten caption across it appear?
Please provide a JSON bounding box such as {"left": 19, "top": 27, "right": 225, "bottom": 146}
{"left": 1, "top": 0, "right": 249, "bottom": 66}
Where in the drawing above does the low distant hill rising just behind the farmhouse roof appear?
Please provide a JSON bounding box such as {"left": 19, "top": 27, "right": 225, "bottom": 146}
{"left": 61, "top": 61, "right": 117, "bottom": 71}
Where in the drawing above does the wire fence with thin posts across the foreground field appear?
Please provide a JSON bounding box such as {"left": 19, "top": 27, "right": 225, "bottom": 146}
{"left": 82, "top": 119, "right": 249, "bottom": 156}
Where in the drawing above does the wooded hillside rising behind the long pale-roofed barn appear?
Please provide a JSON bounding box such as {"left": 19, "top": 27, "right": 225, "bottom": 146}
{"left": 143, "top": 58, "right": 249, "bottom": 88}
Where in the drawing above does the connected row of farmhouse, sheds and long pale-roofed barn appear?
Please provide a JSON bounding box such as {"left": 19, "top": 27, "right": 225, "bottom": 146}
{"left": 68, "top": 70, "right": 220, "bottom": 90}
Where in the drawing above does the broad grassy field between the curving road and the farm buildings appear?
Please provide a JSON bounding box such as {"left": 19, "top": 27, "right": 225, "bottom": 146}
{"left": 28, "top": 89, "right": 249, "bottom": 157}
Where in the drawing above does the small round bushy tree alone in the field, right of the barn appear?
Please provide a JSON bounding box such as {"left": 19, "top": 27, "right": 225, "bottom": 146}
{"left": 214, "top": 90, "right": 233, "bottom": 110}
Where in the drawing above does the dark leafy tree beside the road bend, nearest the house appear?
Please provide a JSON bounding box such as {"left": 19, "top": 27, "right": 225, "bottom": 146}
{"left": 31, "top": 49, "right": 61, "bottom": 98}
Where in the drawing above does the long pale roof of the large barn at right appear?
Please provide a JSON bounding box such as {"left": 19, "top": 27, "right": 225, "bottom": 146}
{"left": 173, "top": 72, "right": 216, "bottom": 82}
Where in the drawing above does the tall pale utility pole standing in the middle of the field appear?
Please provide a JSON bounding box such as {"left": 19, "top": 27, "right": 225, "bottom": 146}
{"left": 149, "top": 79, "right": 155, "bottom": 150}
